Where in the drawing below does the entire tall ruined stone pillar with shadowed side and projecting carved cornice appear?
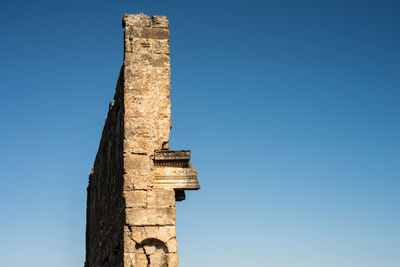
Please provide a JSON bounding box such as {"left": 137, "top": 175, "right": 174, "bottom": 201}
{"left": 85, "top": 14, "right": 200, "bottom": 267}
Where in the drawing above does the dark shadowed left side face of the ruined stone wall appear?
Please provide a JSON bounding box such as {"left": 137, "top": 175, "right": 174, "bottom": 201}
{"left": 86, "top": 68, "right": 125, "bottom": 266}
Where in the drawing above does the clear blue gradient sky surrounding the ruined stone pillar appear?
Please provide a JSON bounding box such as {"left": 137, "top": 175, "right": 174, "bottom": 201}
{"left": 0, "top": 0, "right": 400, "bottom": 267}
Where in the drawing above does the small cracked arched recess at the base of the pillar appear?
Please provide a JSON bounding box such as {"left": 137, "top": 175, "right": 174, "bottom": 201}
{"left": 138, "top": 238, "right": 168, "bottom": 267}
